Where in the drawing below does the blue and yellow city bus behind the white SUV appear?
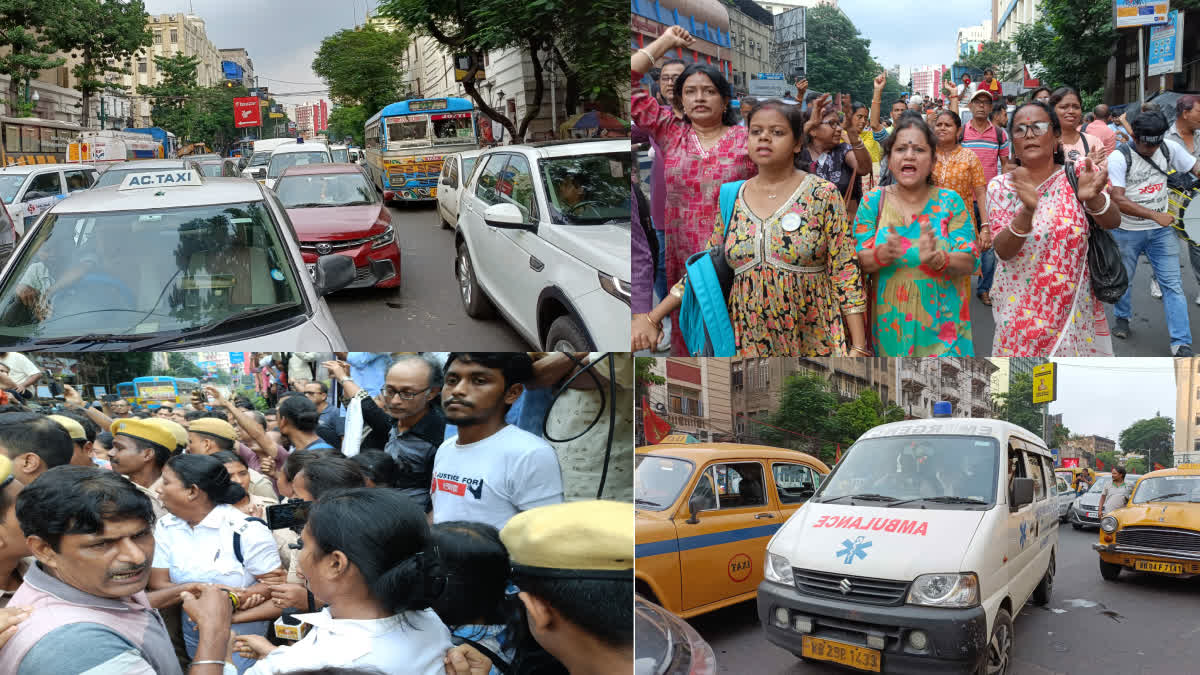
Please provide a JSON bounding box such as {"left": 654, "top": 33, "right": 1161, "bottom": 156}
{"left": 364, "top": 97, "right": 479, "bottom": 202}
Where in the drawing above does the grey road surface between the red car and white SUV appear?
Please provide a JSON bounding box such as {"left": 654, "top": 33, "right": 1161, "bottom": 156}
{"left": 325, "top": 203, "right": 529, "bottom": 352}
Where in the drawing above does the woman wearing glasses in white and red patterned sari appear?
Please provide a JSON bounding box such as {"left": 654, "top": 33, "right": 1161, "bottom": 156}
{"left": 988, "top": 101, "right": 1121, "bottom": 357}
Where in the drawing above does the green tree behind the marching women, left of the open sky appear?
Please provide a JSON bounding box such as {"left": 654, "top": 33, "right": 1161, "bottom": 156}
{"left": 808, "top": 5, "right": 878, "bottom": 103}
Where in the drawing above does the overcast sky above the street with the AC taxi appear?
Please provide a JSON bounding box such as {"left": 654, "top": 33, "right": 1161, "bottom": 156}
{"left": 145, "top": 0, "right": 378, "bottom": 103}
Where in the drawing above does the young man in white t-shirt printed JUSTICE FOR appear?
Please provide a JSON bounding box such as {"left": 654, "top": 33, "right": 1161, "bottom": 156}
{"left": 431, "top": 352, "right": 563, "bottom": 530}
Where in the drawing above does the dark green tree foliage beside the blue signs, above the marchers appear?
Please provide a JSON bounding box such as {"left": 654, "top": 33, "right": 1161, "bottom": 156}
{"left": 1013, "top": 0, "right": 1118, "bottom": 97}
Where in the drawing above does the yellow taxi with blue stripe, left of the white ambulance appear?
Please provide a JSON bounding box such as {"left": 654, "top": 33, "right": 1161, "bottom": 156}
{"left": 634, "top": 436, "right": 829, "bottom": 619}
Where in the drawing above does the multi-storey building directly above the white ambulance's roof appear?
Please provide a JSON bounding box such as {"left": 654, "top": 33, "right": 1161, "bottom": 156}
{"left": 896, "top": 357, "right": 996, "bottom": 417}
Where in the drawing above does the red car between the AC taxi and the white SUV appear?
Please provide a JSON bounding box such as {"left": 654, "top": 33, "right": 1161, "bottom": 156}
{"left": 275, "top": 163, "right": 400, "bottom": 288}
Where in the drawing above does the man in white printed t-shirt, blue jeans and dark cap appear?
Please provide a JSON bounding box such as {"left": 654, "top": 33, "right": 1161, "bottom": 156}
{"left": 1108, "top": 110, "right": 1200, "bottom": 357}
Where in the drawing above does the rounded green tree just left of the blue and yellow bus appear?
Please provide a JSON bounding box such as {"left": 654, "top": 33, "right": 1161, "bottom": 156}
{"left": 312, "top": 25, "right": 408, "bottom": 118}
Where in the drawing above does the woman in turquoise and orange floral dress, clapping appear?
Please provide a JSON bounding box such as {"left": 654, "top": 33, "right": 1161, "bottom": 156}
{"left": 854, "top": 115, "right": 979, "bottom": 357}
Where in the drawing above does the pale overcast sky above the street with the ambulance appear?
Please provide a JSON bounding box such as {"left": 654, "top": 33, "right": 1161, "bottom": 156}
{"left": 1050, "top": 358, "right": 1175, "bottom": 449}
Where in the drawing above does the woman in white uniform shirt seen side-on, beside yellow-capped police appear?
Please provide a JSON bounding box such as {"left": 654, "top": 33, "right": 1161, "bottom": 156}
{"left": 150, "top": 454, "right": 283, "bottom": 673}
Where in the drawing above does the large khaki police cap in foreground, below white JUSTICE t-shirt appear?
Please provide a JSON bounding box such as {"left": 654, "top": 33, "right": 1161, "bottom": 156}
{"left": 500, "top": 501, "right": 634, "bottom": 579}
